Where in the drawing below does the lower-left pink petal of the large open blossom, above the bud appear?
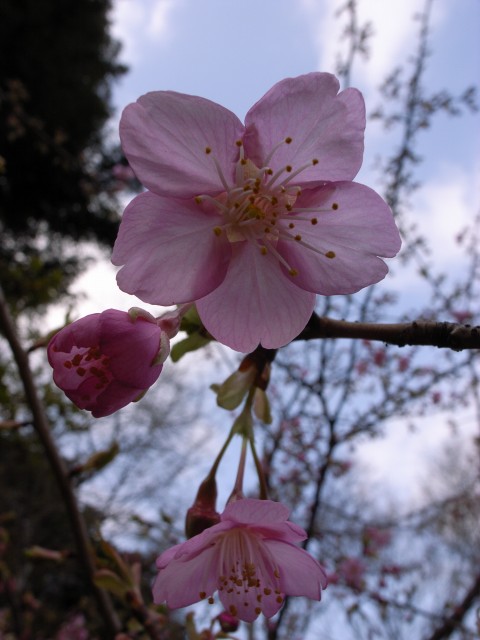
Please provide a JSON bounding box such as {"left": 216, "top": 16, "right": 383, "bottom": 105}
{"left": 112, "top": 192, "right": 231, "bottom": 306}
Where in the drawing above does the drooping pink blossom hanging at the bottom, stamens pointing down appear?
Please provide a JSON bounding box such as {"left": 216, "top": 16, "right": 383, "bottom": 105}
{"left": 153, "top": 498, "right": 327, "bottom": 622}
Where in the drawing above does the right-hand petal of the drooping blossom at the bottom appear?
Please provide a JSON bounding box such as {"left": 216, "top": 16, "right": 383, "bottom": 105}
{"left": 265, "top": 540, "right": 327, "bottom": 600}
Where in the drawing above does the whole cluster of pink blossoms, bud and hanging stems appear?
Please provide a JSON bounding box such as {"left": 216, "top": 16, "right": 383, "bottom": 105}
{"left": 48, "top": 73, "right": 400, "bottom": 624}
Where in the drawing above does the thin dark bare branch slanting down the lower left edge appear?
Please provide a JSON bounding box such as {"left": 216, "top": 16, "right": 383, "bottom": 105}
{"left": 0, "top": 286, "right": 121, "bottom": 638}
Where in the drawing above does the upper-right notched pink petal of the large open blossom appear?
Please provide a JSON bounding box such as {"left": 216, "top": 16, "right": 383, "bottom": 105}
{"left": 244, "top": 73, "right": 365, "bottom": 186}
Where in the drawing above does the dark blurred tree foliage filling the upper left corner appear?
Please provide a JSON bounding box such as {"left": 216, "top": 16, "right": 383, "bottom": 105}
{"left": 0, "top": 0, "right": 125, "bottom": 308}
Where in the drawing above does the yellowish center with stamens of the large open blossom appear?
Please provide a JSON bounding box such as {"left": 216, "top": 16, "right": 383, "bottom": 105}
{"left": 195, "top": 137, "right": 339, "bottom": 276}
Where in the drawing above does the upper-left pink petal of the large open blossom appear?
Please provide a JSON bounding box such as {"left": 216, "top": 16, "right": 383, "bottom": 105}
{"left": 120, "top": 91, "right": 244, "bottom": 198}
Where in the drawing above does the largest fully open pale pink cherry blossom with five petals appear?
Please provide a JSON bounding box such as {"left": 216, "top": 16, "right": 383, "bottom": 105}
{"left": 112, "top": 73, "right": 400, "bottom": 352}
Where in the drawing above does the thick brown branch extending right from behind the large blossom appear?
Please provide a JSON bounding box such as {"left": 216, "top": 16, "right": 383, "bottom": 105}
{"left": 296, "top": 313, "right": 480, "bottom": 351}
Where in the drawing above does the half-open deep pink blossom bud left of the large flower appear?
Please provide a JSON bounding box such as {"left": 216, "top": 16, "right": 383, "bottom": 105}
{"left": 47, "top": 309, "right": 169, "bottom": 418}
